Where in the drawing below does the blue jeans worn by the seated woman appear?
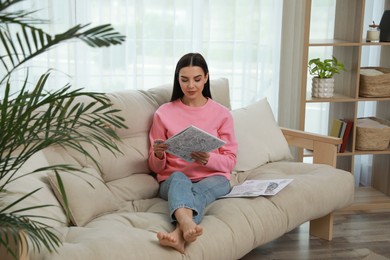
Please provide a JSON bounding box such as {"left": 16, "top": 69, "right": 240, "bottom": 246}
{"left": 159, "top": 172, "right": 230, "bottom": 224}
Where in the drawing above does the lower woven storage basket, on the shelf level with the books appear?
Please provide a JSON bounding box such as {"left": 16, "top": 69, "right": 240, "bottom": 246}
{"left": 356, "top": 117, "right": 390, "bottom": 150}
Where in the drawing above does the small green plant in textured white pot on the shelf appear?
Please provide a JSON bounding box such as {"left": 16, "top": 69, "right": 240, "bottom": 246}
{"left": 308, "top": 56, "right": 345, "bottom": 98}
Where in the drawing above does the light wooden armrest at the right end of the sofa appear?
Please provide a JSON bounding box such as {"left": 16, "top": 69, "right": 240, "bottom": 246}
{"left": 281, "top": 127, "right": 342, "bottom": 167}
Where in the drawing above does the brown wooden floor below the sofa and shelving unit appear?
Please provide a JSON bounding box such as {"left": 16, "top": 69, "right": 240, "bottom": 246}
{"left": 241, "top": 210, "right": 390, "bottom": 260}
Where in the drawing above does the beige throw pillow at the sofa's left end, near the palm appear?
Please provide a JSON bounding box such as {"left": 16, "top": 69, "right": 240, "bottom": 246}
{"left": 48, "top": 168, "right": 119, "bottom": 226}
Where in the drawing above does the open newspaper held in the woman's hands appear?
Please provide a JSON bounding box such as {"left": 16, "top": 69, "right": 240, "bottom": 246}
{"left": 165, "top": 125, "right": 226, "bottom": 162}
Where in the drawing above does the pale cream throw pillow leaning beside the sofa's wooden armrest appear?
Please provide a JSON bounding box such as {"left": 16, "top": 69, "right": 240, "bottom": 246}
{"left": 231, "top": 98, "right": 292, "bottom": 171}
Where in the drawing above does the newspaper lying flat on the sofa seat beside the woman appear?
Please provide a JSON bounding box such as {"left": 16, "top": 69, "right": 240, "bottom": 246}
{"left": 220, "top": 179, "right": 293, "bottom": 198}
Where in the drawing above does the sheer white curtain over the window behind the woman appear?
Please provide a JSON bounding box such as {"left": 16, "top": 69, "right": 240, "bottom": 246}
{"left": 7, "top": 0, "right": 283, "bottom": 110}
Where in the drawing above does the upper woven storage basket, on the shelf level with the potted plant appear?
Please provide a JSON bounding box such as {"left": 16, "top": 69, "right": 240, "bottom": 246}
{"left": 359, "top": 67, "right": 390, "bottom": 97}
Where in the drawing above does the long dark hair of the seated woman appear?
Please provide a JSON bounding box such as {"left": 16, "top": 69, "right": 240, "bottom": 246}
{"left": 171, "top": 53, "right": 212, "bottom": 101}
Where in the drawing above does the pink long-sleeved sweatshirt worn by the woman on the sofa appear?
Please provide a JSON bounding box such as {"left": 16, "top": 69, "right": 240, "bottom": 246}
{"left": 149, "top": 99, "right": 237, "bottom": 182}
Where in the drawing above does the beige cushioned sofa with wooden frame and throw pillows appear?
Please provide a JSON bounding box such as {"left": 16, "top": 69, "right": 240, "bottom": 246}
{"left": 9, "top": 79, "right": 354, "bottom": 260}
